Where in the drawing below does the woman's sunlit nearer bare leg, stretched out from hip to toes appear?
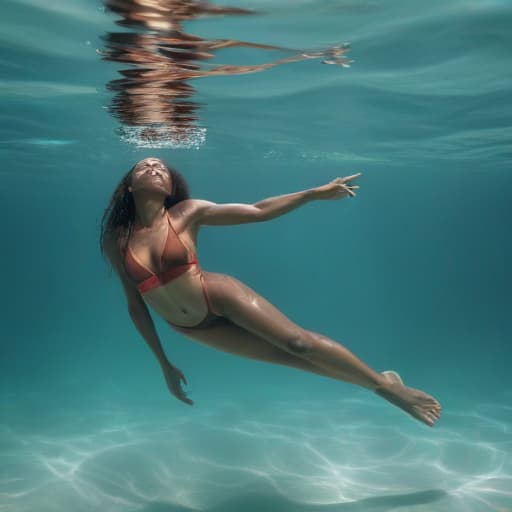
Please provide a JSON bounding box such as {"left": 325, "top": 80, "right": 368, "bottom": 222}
{"left": 191, "top": 272, "right": 441, "bottom": 426}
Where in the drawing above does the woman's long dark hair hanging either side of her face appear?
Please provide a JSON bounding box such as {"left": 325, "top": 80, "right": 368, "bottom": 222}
{"left": 100, "top": 162, "right": 190, "bottom": 264}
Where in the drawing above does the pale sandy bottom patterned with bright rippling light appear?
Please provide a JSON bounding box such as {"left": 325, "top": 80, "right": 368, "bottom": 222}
{"left": 0, "top": 394, "right": 512, "bottom": 512}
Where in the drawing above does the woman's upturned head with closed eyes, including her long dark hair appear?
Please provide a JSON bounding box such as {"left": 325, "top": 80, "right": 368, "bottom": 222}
{"left": 100, "top": 158, "right": 190, "bottom": 258}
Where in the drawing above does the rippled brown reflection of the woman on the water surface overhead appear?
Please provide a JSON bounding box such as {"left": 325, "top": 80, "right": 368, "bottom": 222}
{"left": 98, "top": 0, "right": 350, "bottom": 147}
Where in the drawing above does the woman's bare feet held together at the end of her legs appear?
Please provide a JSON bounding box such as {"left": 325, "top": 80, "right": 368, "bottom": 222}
{"left": 375, "top": 371, "right": 441, "bottom": 427}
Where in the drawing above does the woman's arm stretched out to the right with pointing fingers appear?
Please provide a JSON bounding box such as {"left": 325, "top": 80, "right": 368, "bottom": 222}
{"left": 192, "top": 173, "right": 361, "bottom": 226}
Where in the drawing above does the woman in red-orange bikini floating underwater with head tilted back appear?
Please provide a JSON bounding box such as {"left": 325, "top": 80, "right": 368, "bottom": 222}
{"left": 101, "top": 158, "right": 441, "bottom": 426}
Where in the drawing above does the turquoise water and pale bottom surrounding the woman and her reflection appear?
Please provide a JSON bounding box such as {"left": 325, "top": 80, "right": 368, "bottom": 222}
{"left": 0, "top": 0, "right": 512, "bottom": 512}
